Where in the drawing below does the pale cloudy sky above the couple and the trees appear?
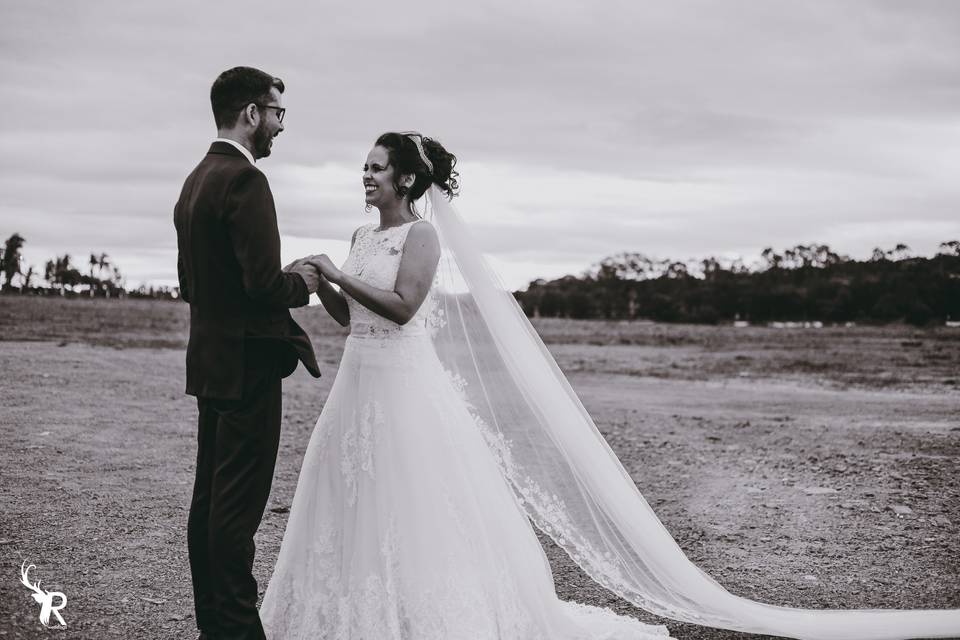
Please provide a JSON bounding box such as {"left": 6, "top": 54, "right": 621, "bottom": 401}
{"left": 0, "top": 0, "right": 960, "bottom": 287}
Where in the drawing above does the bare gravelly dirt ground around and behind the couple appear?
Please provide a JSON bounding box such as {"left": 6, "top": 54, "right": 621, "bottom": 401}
{"left": 0, "top": 296, "right": 960, "bottom": 640}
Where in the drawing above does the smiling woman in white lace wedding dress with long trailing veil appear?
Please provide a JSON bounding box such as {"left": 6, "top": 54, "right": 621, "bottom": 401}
{"left": 261, "top": 133, "right": 960, "bottom": 640}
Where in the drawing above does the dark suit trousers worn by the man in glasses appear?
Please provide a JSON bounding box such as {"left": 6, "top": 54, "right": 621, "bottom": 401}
{"left": 187, "top": 342, "right": 282, "bottom": 640}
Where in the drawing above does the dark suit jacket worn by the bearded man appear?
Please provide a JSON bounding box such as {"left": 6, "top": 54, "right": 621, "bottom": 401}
{"left": 173, "top": 142, "right": 320, "bottom": 400}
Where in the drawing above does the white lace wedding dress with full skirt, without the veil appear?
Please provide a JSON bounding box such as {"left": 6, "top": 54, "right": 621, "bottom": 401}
{"left": 260, "top": 222, "right": 667, "bottom": 640}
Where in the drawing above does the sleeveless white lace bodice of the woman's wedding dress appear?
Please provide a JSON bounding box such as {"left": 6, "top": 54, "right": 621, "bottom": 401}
{"left": 341, "top": 220, "right": 434, "bottom": 339}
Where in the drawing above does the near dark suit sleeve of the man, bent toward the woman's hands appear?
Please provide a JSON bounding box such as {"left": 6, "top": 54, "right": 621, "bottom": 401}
{"left": 224, "top": 167, "right": 310, "bottom": 308}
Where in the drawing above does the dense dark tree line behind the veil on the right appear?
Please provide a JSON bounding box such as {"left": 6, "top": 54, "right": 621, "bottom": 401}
{"left": 514, "top": 240, "right": 960, "bottom": 325}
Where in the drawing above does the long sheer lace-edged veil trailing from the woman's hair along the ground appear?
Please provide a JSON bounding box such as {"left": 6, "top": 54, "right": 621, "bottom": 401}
{"left": 424, "top": 186, "right": 960, "bottom": 640}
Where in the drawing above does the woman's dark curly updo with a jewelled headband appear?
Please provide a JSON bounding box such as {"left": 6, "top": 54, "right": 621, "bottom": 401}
{"left": 376, "top": 131, "right": 460, "bottom": 203}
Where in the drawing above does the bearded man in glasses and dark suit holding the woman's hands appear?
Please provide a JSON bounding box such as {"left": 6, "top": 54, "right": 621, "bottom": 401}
{"left": 174, "top": 67, "right": 320, "bottom": 640}
